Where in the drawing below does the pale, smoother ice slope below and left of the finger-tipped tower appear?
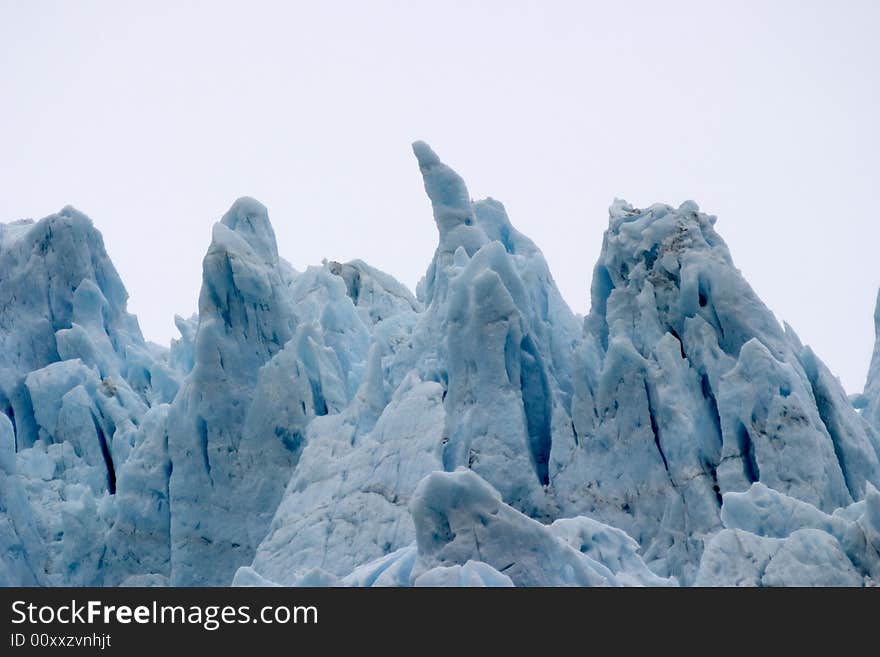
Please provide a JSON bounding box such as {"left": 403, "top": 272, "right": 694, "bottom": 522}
{"left": 246, "top": 377, "right": 443, "bottom": 584}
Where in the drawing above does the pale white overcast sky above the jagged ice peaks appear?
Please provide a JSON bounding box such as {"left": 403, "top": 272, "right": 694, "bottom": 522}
{"left": 0, "top": 0, "right": 880, "bottom": 391}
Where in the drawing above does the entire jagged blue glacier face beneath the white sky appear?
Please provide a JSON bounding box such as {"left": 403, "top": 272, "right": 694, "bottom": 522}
{"left": 0, "top": 142, "right": 880, "bottom": 586}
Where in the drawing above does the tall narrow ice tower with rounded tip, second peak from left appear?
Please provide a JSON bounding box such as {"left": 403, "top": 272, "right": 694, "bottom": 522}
{"left": 168, "top": 198, "right": 306, "bottom": 585}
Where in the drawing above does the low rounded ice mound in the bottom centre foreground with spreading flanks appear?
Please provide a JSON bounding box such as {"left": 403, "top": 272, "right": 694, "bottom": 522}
{"left": 234, "top": 468, "right": 676, "bottom": 586}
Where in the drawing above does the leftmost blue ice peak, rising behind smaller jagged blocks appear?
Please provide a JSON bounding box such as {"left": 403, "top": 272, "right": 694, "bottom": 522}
{"left": 0, "top": 206, "right": 177, "bottom": 448}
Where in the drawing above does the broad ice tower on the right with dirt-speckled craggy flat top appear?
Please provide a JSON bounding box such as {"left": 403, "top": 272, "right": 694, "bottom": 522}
{"left": 556, "top": 201, "right": 880, "bottom": 583}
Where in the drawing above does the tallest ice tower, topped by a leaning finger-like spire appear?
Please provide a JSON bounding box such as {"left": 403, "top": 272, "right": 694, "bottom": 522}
{"left": 392, "top": 142, "right": 581, "bottom": 518}
